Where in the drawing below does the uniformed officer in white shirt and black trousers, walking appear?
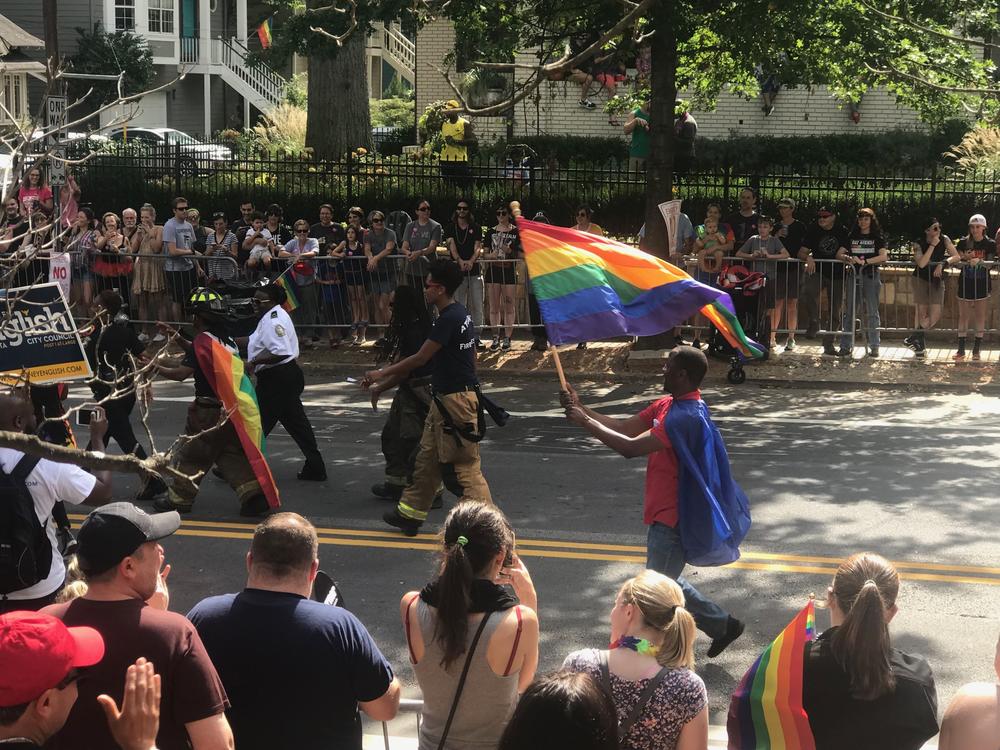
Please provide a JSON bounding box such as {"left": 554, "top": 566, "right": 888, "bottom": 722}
{"left": 240, "top": 284, "right": 326, "bottom": 482}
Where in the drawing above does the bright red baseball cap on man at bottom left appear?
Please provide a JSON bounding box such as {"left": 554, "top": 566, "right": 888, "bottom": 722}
{"left": 0, "top": 612, "right": 104, "bottom": 708}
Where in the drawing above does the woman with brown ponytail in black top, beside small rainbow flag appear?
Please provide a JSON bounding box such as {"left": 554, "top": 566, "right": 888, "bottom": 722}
{"left": 802, "top": 552, "right": 938, "bottom": 750}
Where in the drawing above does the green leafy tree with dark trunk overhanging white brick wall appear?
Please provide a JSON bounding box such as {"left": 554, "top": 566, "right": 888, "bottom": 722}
{"left": 436, "top": 0, "right": 1000, "bottom": 251}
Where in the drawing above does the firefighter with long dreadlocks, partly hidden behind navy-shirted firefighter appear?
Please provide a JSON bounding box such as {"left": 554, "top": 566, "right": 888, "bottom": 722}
{"left": 370, "top": 286, "right": 442, "bottom": 508}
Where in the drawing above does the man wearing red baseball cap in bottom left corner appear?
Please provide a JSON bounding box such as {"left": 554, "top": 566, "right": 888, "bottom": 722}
{"left": 0, "top": 611, "right": 104, "bottom": 748}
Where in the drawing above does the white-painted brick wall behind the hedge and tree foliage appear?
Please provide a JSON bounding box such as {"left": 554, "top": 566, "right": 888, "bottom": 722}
{"left": 416, "top": 20, "right": 923, "bottom": 147}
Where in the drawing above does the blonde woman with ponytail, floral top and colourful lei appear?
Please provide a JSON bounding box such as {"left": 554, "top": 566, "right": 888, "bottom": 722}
{"left": 563, "top": 570, "right": 708, "bottom": 750}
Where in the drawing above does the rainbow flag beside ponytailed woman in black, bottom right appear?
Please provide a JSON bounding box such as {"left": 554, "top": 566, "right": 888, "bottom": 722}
{"left": 726, "top": 599, "right": 816, "bottom": 750}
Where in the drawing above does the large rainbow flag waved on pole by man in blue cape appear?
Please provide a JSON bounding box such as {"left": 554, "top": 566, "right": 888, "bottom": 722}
{"left": 517, "top": 219, "right": 764, "bottom": 359}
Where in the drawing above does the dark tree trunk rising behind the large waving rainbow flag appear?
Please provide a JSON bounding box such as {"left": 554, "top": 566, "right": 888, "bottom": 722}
{"left": 635, "top": 0, "right": 677, "bottom": 349}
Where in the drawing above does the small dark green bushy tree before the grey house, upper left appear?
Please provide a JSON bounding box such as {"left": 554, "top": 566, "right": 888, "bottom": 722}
{"left": 68, "top": 23, "right": 156, "bottom": 106}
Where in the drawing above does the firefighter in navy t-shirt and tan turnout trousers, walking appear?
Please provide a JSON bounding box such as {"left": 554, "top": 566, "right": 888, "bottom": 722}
{"left": 362, "top": 261, "right": 493, "bottom": 536}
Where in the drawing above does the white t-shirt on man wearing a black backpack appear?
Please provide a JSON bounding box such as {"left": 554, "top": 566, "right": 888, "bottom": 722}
{"left": 0, "top": 448, "right": 97, "bottom": 600}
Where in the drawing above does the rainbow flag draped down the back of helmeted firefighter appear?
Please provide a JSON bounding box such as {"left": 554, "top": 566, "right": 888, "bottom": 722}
{"left": 194, "top": 333, "right": 281, "bottom": 508}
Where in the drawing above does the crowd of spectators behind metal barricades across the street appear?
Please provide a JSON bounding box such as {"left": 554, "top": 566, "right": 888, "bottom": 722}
{"left": 9, "top": 165, "right": 1000, "bottom": 360}
